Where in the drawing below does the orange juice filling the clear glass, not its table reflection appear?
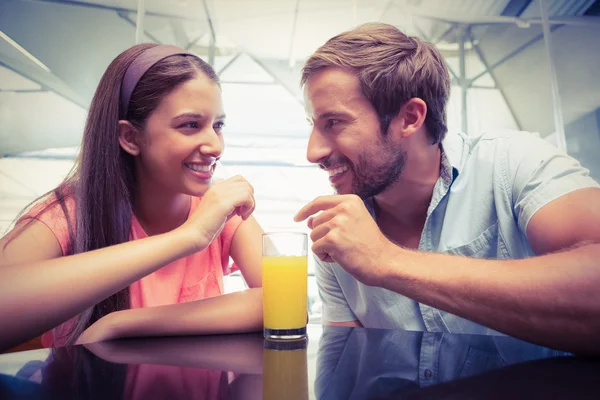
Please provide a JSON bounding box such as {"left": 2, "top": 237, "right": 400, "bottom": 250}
{"left": 262, "top": 256, "right": 308, "bottom": 329}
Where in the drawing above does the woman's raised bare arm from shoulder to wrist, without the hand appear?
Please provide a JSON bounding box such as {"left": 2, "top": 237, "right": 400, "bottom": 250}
{"left": 0, "top": 221, "right": 197, "bottom": 350}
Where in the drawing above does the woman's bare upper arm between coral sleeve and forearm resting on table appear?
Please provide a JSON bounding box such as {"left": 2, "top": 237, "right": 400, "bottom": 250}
{"left": 229, "top": 217, "right": 263, "bottom": 288}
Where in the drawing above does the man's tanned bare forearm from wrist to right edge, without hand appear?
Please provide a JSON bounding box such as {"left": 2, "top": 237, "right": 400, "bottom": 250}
{"left": 381, "top": 244, "right": 600, "bottom": 354}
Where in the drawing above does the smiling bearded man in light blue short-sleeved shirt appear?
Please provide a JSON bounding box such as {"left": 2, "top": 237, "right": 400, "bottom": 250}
{"left": 296, "top": 24, "right": 600, "bottom": 352}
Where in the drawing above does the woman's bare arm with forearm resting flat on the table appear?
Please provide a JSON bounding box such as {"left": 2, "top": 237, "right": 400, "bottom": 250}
{"left": 74, "top": 217, "right": 263, "bottom": 343}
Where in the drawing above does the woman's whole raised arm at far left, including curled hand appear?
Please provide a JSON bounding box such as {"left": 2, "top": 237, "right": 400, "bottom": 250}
{"left": 0, "top": 177, "right": 255, "bottom": 351}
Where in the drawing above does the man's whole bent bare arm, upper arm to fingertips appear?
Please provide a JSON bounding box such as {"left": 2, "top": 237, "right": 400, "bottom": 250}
{"left": 297, "top": 188, "right": 600, "bottom": 354}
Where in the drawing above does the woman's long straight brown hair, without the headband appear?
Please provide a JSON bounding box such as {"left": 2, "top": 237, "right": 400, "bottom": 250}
{"left": 11, "top": 44, "right": 218, "bottom": 344}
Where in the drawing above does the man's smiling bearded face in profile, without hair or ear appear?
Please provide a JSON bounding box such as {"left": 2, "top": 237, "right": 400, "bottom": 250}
{"left": 304, "top": 67, "right": 406, "bottom": 199}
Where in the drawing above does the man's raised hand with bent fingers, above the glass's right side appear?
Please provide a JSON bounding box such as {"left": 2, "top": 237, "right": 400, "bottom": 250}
{"left": 294, "top": 195, "right": 399, "bottom": 286}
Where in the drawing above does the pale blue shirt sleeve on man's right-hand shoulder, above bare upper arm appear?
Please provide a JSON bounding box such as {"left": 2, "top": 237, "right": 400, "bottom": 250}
{"left": 508, "top": 132, "right": 600, "bottom": 232}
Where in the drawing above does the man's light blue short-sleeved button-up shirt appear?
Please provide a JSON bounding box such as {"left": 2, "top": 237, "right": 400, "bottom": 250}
{"left": 315, "top": 130, "right": 599, "bottom": 334}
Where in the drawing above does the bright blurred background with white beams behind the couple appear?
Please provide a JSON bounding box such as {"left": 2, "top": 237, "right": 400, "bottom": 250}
{"left": 0, "top": 0, "right": 600, "bottom": 322}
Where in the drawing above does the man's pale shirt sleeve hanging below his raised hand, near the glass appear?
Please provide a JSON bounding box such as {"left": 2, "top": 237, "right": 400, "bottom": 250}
{"left": 315, "top": 256, "right": 358, "bottom": 322}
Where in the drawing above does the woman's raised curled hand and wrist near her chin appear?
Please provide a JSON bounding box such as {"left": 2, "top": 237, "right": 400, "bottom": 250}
{"left": 179, "top": 175, "right": 255, "bottom": 251}
